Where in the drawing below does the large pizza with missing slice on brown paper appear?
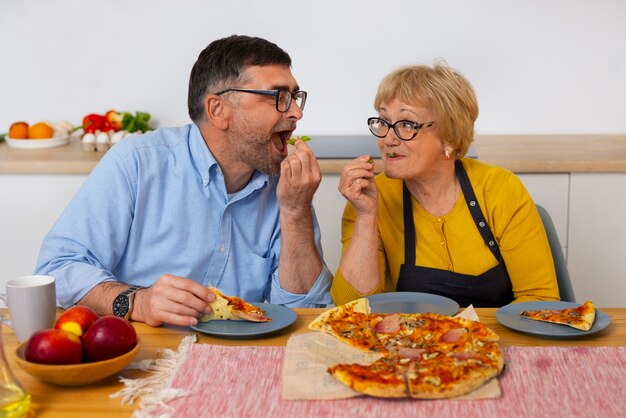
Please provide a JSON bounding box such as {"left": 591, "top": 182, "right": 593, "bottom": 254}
{"left": 309, "top": 298, "right": 504, "bottom": 399}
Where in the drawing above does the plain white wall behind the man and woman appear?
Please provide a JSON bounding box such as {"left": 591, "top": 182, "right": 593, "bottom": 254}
{"left": 0, "top": 0, "right": 626, "bottom": 135}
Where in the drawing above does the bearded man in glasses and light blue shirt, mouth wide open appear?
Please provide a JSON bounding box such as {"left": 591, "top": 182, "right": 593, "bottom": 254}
{"left": 36, "top": 36, "right": 332, "bottom": 326}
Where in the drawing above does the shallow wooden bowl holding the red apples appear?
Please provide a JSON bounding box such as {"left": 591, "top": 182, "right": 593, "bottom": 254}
{"left": 15, "top": 339, "right": 139, "bottom": 386}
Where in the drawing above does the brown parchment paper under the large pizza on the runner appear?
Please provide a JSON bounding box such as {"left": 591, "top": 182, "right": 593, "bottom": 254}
{"left": 282, "top": 305, "right": 501, "bottom": 400}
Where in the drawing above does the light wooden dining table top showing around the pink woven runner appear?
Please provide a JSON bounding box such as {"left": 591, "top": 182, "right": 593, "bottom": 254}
{"left": 2, "top": 308, "right": 626, "bottom": 418}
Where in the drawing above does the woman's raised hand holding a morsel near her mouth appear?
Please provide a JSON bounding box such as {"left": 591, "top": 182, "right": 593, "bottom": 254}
{"left": 339, "top": 155, "right": 378, "bottom": 215}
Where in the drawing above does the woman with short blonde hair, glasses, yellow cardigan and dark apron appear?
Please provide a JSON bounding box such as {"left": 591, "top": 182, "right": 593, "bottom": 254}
{"left": 331, "top": 63, "right": 559, "bottom": 306}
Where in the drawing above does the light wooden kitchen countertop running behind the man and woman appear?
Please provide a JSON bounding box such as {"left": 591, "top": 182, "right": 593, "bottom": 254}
{"left": 0, "top": 134, "right": 626, "bottom": 174}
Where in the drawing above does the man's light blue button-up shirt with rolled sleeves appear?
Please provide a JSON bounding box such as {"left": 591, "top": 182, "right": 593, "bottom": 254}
{"left": 35, "top": 125, "right": 332, "bottom": 308}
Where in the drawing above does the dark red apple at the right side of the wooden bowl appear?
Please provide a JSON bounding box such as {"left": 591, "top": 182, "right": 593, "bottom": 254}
{"left": 83, "top": 315, "right": 137, "bottom": 361}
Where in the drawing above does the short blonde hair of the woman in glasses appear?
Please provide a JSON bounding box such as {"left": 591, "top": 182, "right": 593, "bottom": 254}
{"left": 374, "top": 61, "right": 478, "bottom": 158}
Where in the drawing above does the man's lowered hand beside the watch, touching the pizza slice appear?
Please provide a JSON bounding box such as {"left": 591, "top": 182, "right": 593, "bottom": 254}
{"left": 131, "top": 274, "right": 215, "bottom": 326}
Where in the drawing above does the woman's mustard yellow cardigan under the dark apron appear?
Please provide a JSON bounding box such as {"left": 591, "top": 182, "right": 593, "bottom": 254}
{"left": 331, "top": 158, "right": 559, "bottom": 305}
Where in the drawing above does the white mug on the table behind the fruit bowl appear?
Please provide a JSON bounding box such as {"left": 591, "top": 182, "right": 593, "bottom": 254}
{"left": 0, "top": 276, "right": 56, "bottom": 343}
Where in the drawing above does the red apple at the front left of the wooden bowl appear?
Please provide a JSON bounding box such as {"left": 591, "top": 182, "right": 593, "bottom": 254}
{"left": 25, "top": 329, "right": 83, "bottom": 364}
